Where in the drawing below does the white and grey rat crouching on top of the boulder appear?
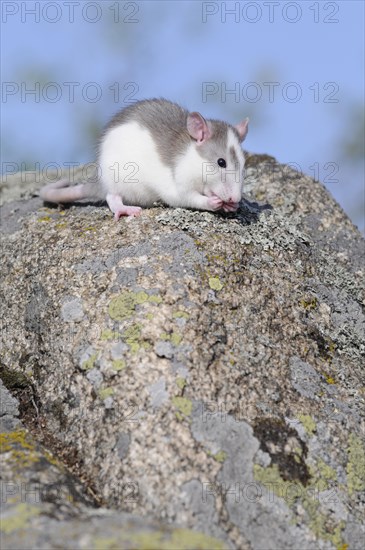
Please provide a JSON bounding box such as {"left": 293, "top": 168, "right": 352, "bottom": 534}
{"left": 40, "top": 99, "right": 248, "bottom": 220}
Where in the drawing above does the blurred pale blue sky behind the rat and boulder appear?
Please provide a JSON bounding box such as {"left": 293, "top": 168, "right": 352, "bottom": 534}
{"left": 1, "top": 0, "right": 364, "bottom": 231}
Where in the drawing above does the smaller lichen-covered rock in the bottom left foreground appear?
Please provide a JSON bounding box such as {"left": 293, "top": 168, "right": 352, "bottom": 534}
{"left": 0, "top": 380, "right": 223, "bottom": 550}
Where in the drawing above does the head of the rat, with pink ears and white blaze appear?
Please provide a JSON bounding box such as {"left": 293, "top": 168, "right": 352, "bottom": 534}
{"left": 187, "top": 113, "right": 248, "bottom": 210}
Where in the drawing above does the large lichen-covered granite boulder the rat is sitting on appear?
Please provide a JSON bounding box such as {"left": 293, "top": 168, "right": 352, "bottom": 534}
{"left": 2, "top": 155, "right": 365, "bottom": 550}
